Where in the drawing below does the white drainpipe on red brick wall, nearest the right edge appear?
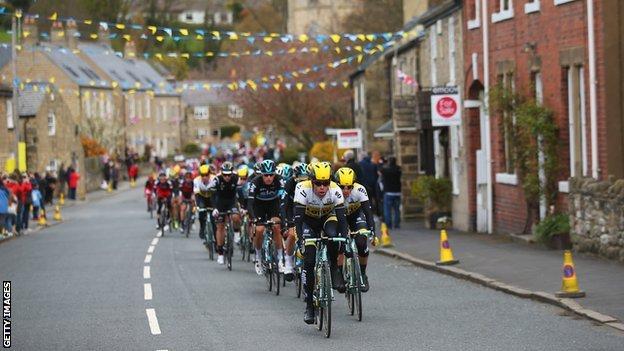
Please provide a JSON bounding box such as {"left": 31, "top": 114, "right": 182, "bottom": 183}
{"left": 587, "top": 0, "right": 600, "bottom": 179}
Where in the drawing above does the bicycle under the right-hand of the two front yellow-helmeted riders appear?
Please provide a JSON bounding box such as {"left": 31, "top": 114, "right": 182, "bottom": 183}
{"left": 343, "top": 229, "right": 372, "bottom": 321}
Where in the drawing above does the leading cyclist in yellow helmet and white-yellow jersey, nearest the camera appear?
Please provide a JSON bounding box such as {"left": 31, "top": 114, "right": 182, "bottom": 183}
{"left": 294, "top": 162, "right": 348, "bottom": 324}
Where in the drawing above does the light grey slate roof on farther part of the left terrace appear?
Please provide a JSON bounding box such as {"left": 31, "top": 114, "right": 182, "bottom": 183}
{"left": 78, "top": 43, "right": 176, "bottom": 95}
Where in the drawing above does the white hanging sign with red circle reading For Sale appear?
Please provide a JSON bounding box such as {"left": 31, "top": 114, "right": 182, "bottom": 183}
{"left": 431, "top": 86, "right": 461, "bottom": 127}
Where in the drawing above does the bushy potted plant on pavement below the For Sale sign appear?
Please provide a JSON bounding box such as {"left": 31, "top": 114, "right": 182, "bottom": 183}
{"left": 412, "top": 176, "right": 453, "bottom": 228}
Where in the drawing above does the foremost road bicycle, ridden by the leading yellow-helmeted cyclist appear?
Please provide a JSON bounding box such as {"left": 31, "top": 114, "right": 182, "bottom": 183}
{"left": 305, "top": 236, "right": 345, "bottom": 338}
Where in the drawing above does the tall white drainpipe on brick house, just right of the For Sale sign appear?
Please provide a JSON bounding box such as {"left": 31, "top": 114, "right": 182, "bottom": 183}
{"left": 481, "top": 0, "right": 494, "bottom": 234}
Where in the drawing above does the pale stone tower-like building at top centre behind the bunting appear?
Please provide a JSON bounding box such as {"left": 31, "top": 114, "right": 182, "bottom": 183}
{"left": 288, "top": 0, "right": 362, "bottom": 34}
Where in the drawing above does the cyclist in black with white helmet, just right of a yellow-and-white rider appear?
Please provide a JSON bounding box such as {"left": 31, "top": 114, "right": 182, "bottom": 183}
{"left": 208, "top": 161, "right": 241, "bottom": 264}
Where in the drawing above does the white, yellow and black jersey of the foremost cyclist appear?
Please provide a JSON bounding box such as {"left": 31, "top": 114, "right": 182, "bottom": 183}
{"left": 294, "top": 180, "right": 344, "bottom": 218}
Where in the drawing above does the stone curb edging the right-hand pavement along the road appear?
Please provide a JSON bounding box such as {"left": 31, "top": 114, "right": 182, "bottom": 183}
{"left": 373, "top": 248, "right": 624, "bottom": 332}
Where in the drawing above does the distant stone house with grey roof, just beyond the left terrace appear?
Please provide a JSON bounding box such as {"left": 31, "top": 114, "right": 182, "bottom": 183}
{"left": 180, "top": 81, "right": 244, "bottom": 145}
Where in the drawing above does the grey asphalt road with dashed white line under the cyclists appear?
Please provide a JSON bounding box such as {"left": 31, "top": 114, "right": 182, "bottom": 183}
{"left": 0, "top": 189, "right": 624, "bottom": 350}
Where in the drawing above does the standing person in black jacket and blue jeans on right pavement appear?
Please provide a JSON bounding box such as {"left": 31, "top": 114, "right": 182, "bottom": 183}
{"left": 380, "top": 157, "right": 401, "bottom": 229}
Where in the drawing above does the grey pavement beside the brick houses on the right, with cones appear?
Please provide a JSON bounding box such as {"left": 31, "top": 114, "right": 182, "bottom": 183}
{"left": 376, "top": 222, "right": 624, "bottom": 321}
